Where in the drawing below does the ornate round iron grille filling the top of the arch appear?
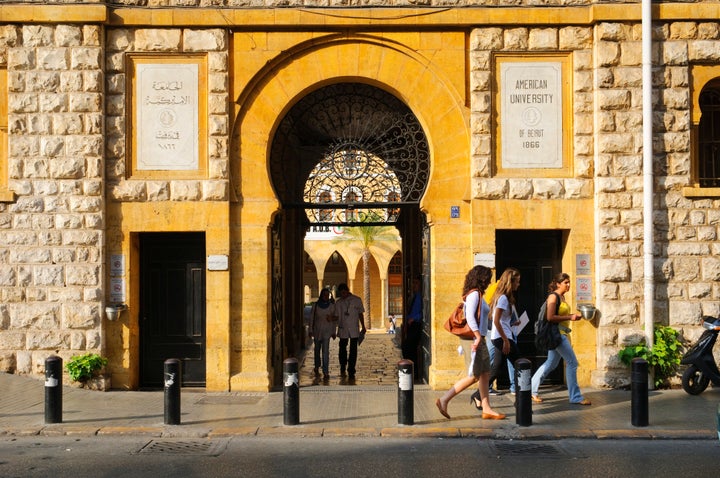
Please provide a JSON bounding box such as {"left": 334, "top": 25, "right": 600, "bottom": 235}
{"left": 270, "top": 83, "right": 430, "bottom": 225}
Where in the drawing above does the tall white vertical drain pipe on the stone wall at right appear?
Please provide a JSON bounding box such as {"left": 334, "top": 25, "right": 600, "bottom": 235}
{"left": 642, "top": 0, "right": 655, "bottom": 354}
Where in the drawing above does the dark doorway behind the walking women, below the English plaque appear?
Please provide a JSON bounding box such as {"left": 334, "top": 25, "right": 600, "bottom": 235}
{"left": 495, "top": 230, "right": 567, "bottom": 385}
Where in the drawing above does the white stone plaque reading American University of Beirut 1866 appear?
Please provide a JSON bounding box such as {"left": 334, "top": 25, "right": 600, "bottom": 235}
{"left": 500, "top": 62, "right": 563, "bottom": 169}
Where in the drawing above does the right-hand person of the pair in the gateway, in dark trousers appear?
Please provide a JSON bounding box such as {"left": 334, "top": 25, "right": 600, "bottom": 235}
{"left": 335, "top": 283, "right": 366, "bottom": 382}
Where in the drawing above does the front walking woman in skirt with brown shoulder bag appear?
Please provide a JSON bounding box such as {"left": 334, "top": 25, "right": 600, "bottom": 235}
{"left": 435, "top": 265, "right": 505, "bottom": 420}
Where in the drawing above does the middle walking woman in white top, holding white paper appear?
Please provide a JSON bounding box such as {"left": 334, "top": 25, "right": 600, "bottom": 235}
{"left": 490, "top": 267, "right": 520, "bottom": 398}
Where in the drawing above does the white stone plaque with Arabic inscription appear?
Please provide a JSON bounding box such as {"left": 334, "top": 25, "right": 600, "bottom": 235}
{"left": 135, "top": 63, "right": 199, "bottom": 171}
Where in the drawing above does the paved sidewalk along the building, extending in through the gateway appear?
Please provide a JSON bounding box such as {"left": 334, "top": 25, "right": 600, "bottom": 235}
{"left": 0, "top": 334, "right": 720, "bottom": 440}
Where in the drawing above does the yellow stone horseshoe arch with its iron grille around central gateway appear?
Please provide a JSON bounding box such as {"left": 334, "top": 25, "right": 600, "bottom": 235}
{"left": 235, "top": 35, "right": 471, "bottom": 390}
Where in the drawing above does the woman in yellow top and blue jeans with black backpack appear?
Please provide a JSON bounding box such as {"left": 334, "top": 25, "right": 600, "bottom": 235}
{"left": 531, "top": 272, "right": 591, "bottom": 405}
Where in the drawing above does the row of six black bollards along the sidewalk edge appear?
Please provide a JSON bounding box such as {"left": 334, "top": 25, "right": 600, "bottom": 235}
{"left": 40, "top": 356, "right": 652, "bottom": 430}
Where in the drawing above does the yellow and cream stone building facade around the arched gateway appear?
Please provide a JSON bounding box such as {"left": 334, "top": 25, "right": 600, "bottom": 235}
{"left": 0, "top": 0, "right": 720, "bottom": 390}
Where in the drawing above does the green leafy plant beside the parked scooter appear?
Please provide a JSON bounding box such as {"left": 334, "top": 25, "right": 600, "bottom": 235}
{"left": 618, "top": 325, "right": 683, "bottom": 388}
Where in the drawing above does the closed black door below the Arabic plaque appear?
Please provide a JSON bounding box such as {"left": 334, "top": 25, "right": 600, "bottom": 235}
{"left": 139, "top": 232, "right": 206, "bottom": 388}
